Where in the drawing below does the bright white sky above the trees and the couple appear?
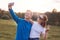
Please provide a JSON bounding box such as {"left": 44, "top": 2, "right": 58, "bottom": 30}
{"left": 0, "top": 0, "right": 60, "bottom": 13}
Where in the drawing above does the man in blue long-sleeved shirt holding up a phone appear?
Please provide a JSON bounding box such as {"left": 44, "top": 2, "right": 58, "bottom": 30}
{"left": 8, "top": 3, "right": 32, "bottom": 40}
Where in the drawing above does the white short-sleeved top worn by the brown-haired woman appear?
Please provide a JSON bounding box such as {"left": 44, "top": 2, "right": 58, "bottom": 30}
{"left": 30, "top": 22, "right": 45, "bottom": 38}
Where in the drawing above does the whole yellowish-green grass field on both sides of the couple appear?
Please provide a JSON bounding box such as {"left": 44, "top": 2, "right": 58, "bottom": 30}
{"left": 0, "top": 19, "right": 60, "bottom": 40}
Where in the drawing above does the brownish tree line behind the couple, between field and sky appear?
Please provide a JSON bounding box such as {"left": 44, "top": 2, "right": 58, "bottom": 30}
{"left": 0, "top": 9, "right": 60, "bottom": 26}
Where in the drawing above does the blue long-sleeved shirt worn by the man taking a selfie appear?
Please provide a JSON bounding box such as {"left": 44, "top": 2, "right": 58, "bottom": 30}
{"left": 9, "top": 9, "right": 32, "bottom": 40}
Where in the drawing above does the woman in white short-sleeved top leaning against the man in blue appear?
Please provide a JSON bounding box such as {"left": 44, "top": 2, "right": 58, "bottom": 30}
{"left": 29, "top": 15, "right": 47, "bottom": 40}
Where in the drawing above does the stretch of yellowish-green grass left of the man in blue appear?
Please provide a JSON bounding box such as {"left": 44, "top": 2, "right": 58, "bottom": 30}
{"left": 0, "top": 20, "right": 16, "bottom": 40}
